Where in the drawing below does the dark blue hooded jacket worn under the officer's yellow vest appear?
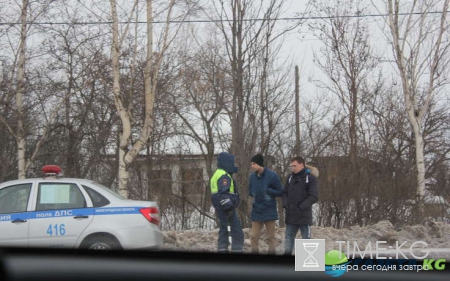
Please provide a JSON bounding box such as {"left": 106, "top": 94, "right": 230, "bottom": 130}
{"left": 211, "top": 152, "right": 239, "bottom": 211}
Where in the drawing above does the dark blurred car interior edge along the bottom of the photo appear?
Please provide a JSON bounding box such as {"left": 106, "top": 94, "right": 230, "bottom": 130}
{"left": 0, "top": 248, "right": 450, "bottom": 281}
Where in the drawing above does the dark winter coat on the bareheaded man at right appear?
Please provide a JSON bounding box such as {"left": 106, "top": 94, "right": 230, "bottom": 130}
{"left": 283, "top": 168, "right": 319, "bottom": 225}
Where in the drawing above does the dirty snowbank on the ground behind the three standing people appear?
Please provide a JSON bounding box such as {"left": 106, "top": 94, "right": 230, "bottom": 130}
{"left": 163, "top": 221, "right": 450, "bottom": 259}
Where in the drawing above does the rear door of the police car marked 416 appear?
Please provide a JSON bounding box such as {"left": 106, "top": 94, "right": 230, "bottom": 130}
{"left": 29, "top": 181, "right": 94, "bottom": 248}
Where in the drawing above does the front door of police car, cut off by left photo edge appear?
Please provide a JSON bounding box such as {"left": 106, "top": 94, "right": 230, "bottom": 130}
{"left": 0, "top": 183, "right": 32, "bottom": 246}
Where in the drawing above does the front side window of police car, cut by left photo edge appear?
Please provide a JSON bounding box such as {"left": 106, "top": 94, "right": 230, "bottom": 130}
{"left": 0, "top": 183, "right": 31, "bottom": 214}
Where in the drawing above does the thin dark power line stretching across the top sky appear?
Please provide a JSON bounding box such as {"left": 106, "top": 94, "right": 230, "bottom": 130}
{"left": 0, "top": 11, "right": 444, "bottom": 26}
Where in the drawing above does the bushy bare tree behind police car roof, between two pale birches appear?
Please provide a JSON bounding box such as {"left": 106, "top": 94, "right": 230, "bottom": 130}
{"left": 37, "top": 1, "right": 110, "bottom": 177}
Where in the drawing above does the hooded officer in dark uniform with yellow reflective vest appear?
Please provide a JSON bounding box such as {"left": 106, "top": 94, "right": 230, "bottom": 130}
{"left": 210, "top": 152, "right": 244, "bottom": 252}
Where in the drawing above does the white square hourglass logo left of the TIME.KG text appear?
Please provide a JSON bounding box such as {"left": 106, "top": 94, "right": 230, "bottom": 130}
{"left": 295, "top": 239, "right": 325, "bottom": 271}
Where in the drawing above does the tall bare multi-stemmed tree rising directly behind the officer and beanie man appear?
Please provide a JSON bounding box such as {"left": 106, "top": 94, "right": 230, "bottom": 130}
{"left": 214, "top": 0, "right": 310, "bottom": 224}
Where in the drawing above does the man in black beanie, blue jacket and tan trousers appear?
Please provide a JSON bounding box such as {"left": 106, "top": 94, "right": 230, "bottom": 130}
{"left": 248, "top": 154, "right": 283, "bottom": 254}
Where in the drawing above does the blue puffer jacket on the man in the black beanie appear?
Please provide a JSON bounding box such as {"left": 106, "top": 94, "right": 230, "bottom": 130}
{"left": 248, "top": 168, "right": 283, "bottom": 222}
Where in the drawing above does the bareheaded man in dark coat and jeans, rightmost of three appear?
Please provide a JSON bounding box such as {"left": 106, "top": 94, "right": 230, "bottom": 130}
{"left": 283, "top": 156, "right": 319, "bottom": 255}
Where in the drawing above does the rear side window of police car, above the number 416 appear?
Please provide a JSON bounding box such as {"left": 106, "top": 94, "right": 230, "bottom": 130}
{"left": 36, "top": 183, "right": 86, "bottom": 211}
